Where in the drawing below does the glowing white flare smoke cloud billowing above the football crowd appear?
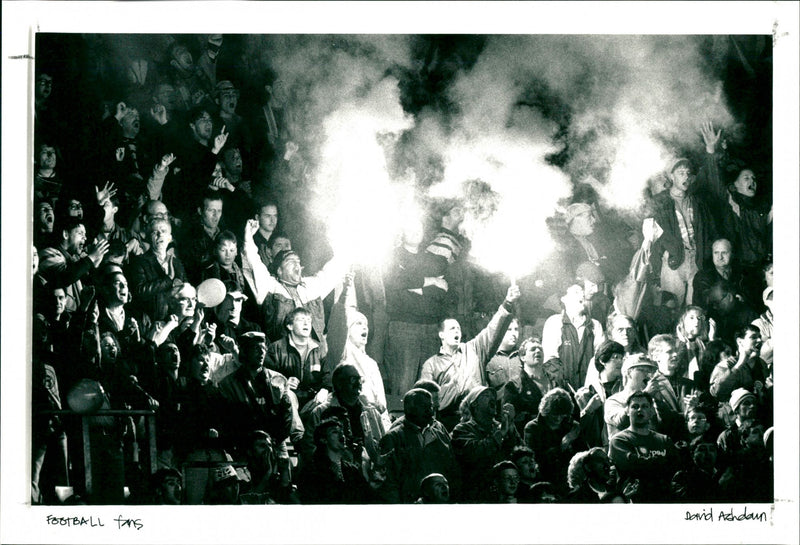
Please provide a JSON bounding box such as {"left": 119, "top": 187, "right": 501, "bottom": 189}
{"left": 245, "top": 36, "right": 733, "bottom": 275}
